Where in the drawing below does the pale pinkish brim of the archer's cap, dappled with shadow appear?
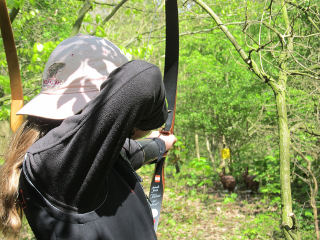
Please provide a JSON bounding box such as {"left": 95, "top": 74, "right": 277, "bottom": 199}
{"left": 17, "top": 91, "right": 99, "bottom": 119}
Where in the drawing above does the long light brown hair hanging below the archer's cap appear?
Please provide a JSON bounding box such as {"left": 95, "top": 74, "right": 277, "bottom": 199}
{"left": 0, "top": 116, "right": 60, "bottom": 235}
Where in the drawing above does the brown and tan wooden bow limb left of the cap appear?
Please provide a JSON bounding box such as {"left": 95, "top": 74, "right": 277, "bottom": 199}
{"left": 0, "top": 0, "right": 23, "bottom": 132}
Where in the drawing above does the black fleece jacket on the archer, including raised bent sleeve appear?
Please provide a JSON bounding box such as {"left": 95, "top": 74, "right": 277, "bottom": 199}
{"left": 20, "top": 61, "right": 167, "bottom": 240}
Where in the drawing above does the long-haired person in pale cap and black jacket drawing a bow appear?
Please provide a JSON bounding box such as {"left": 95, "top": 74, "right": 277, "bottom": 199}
{"left": 0, "top": 35, "right": 176, "bottom": 240}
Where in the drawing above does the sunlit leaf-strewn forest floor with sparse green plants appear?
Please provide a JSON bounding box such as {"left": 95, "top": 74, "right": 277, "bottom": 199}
{"left": 0, "top": 164, "right": 314, "bottom": 240}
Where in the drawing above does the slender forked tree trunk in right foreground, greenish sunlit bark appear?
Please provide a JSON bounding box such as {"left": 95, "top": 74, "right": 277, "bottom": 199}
{"left": 193, "top": 0, "right": 300, "bottom": 240}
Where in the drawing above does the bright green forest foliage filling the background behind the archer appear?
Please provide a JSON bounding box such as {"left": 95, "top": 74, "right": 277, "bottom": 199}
{"left": 0, "top": 0, "right": 320, "bottom": 239}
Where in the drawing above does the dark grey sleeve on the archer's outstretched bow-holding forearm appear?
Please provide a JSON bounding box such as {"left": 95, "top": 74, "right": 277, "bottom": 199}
{"left": 123, "top": 138, "right": 166, "bottom": 170}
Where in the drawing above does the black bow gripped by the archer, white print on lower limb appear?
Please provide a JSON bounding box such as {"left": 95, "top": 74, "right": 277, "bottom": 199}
{"left": 149, "top": 0, "right": 179, "bottom": 231}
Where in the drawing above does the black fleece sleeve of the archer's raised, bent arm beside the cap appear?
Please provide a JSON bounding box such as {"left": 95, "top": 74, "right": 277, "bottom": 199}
{"left": 26, "top": 61, "right": 167, "bottom": 208}
